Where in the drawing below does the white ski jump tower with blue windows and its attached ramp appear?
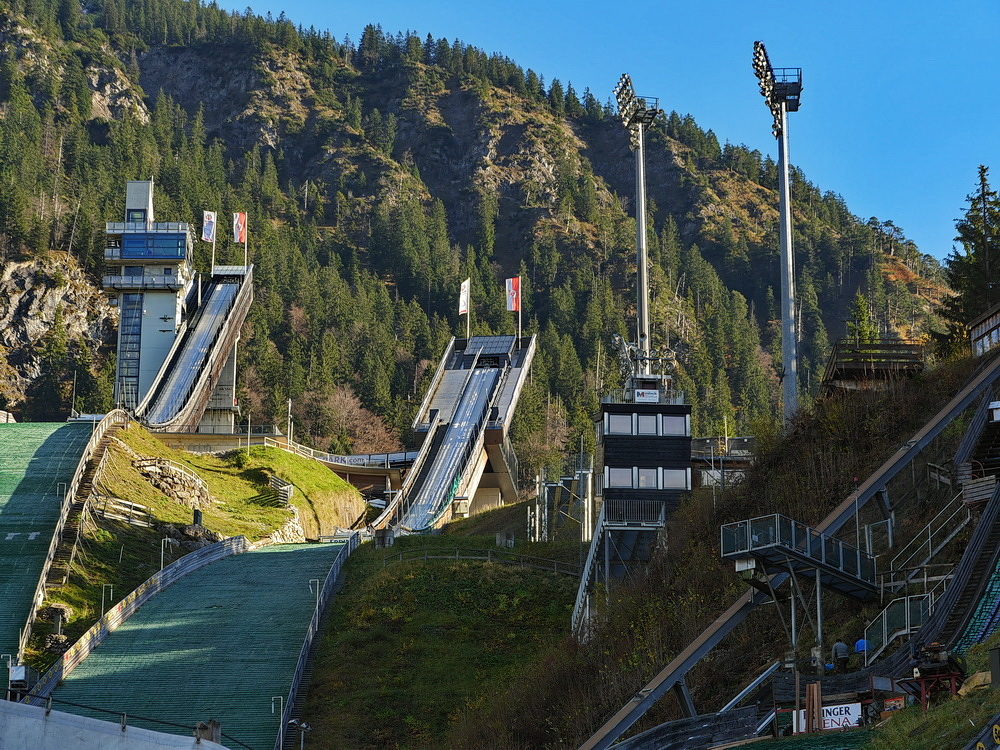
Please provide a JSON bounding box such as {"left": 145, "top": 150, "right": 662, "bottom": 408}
{"left": 103, "top": 181, "right": 252, "bottom": 434}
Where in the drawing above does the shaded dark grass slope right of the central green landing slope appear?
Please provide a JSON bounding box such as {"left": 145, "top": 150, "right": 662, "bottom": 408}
{"left": 305, "top": 536, "right": 577, "bottom": 748}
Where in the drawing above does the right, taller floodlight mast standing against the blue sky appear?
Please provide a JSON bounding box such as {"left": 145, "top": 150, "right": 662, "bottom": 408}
{"left": 753, "top": 42, "right": 802, "bottom": 425}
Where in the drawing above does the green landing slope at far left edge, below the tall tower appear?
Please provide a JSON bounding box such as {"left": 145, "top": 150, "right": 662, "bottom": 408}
{"left": 0, "top": 422, "right": 93, "bottom": 654}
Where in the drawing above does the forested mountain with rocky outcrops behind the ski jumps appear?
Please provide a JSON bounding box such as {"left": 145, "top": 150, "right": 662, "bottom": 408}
{"left": 0, "top": 0, "right": 947, "bottom": 466}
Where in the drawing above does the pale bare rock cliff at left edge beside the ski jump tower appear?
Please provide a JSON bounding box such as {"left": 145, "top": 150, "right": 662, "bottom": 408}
{"left": 0, "top": 252, "right": 118, "bottom": 412}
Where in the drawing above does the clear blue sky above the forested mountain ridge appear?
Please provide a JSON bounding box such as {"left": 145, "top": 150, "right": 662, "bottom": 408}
{"left": 224, "top": 0, "right": 1000, "bottom": 258}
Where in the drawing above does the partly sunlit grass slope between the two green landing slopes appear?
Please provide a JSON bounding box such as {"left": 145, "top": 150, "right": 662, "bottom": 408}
{"left": 27, "top": 424, "right": 365, "bottom": 669}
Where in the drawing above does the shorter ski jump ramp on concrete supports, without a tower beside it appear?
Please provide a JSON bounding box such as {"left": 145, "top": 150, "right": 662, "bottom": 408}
{"left": 373, "top": 336, "right": 535, "bottom": 533}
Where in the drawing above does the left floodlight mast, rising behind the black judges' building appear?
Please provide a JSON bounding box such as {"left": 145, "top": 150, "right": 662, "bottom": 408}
{"left": 614, "top": 73, "right": 662, "bottom": 375}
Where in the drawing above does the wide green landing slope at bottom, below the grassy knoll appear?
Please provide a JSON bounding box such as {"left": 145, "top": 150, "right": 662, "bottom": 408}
{"left": 52, "top": 543, "right": 352, "bottom": 750}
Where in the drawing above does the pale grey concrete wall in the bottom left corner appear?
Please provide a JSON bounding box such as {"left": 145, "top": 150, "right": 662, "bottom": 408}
{"left": 0, "top": 700, "right": 226, "bottom": 750}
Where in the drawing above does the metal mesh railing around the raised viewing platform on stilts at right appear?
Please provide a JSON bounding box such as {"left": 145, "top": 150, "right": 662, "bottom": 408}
{"left": 720, "top": 513, "right": 876, "bottom": 585}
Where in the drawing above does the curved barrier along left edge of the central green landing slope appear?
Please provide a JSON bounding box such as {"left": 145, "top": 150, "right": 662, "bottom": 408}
{"left": 21, "top": 536, "right": 250, "bottom": 706}
